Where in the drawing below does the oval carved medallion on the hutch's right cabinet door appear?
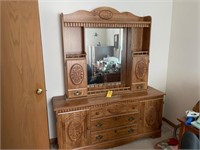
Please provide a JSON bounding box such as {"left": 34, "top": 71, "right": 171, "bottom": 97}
{"left": 135, "top": 60, "right": 147, "bottom": 80}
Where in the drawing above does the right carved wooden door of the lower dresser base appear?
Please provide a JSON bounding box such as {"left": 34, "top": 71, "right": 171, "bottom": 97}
{"left": 140, "top": 98, "right": 163, "bottom": 133}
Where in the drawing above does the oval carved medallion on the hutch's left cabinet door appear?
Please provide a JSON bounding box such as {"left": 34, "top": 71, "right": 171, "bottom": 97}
{"left": 70, "top": 64, "right": 84, "bottom": 85}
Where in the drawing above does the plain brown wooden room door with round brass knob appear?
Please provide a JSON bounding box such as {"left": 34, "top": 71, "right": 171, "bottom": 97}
{"left": 1, "top": 0, "right": 49, "bottom": 149}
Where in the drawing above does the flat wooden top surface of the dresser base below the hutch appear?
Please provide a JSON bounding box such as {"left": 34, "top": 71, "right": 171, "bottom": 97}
{"left": 52, "top": 87, "right": 165, "bottom": 111}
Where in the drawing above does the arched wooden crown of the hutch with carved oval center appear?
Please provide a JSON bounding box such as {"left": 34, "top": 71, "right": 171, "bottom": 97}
{"left": 61, "top": 7, "right": 151, "bottom": 27}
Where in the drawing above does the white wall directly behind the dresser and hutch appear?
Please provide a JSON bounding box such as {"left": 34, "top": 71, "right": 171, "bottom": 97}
{"left": 39, "top": 0, "right": 172, "bottom": 138}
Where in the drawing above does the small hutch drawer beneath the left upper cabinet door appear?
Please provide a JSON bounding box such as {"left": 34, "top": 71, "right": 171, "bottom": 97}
{"left": 67, "top": 88, "right": 87, "bottom": 98}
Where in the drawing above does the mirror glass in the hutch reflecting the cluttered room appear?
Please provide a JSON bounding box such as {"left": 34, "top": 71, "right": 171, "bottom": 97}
{"left": 85, "top": 28, "right": 124, "bottom": 84}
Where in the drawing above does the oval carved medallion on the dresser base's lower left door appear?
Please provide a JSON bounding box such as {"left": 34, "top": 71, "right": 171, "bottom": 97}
{"left": 68, "top": 121, "right": 83, "bottom": 141}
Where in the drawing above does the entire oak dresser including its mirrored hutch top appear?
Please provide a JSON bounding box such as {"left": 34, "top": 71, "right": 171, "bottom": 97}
{"left": 53, "top": 7, "right": 164, "bottom": 149}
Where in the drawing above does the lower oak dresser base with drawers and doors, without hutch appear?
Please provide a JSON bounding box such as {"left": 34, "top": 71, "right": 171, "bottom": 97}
{"left": 53, "top": 87, "right": 164, "bottom": 149}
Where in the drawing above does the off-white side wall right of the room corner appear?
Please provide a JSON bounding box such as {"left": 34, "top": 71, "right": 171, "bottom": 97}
{"left": 164, "top": 0, "right": 200, "bottom": 124}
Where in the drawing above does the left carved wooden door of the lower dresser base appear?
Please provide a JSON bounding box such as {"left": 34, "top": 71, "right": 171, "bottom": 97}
{"left": 57, "top": 110, "right": 90, "bottom": 149}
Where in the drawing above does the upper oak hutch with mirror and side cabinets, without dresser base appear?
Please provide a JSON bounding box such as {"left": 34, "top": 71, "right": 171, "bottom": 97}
{"left": 61, "top": 7, "right": 151, "bottom": 98}
